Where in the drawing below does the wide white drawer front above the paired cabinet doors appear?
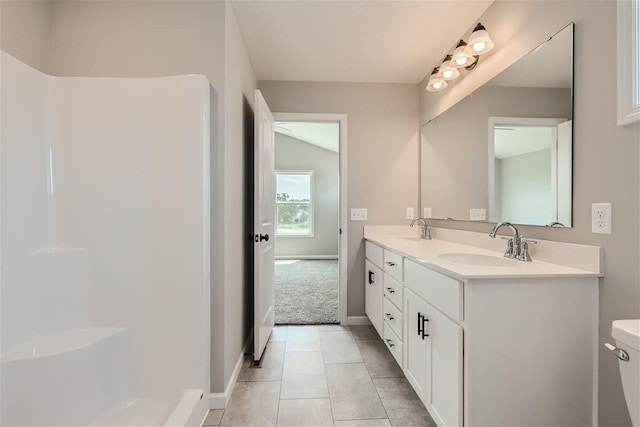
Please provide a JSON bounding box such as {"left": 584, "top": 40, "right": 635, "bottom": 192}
{"left": 404, "top": 261, "right": 463, "bottom": 322}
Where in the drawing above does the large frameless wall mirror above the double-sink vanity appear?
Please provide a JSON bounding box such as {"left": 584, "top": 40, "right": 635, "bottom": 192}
{"left": 420, "top": 24, "right": 573, "bottom": 227}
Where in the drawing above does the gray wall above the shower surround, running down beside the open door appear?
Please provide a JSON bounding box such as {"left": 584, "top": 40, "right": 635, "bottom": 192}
{"left": 0, "top": 0, "right": 257, "bottom": 392}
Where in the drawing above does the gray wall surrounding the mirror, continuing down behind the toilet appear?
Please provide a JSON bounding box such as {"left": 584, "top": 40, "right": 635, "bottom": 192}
{"left": 418, "top": 1, "right": 640, "bottom": 426}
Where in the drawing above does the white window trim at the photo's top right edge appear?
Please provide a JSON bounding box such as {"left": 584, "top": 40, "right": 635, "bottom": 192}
{"left": 617, "top": 0, "right": 640, "bottom": 126}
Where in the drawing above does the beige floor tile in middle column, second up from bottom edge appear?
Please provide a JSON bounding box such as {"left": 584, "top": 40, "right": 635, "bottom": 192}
{"left": 280, "top": 351, "right": 329, "bottom": 399}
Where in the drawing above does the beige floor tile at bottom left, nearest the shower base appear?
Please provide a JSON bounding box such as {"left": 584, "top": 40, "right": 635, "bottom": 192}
{"left": 220, "top": 381, "right": 280, "bottom": 427}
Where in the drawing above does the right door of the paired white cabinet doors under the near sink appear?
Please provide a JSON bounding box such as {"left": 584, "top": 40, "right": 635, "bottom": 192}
{"left": 425, "top": 305, "right": 463, "bottom": 426}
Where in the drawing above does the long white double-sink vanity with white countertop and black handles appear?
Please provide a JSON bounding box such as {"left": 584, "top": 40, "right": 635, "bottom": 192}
{"left": 364, "top": 227, "right": 602, "bottom": 426}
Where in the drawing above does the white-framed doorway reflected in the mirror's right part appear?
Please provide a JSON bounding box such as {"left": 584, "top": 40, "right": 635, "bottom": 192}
{"left": 489, "top": 117, "right": 571, "bottom": 226}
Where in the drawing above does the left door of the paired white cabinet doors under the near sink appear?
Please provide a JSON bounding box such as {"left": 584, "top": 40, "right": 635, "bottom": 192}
{"left": 404, "top": 289, "right": 429, "bottom": 405}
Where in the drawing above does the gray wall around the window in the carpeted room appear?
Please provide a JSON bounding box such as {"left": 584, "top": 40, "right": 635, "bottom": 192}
{"left": 275, "top": 133, "right": 340, "bottom": 258}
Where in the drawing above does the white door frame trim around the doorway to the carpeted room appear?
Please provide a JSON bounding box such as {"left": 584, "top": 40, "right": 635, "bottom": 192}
{"left": 273, "top": 113, "right": 349, "bottom": 325}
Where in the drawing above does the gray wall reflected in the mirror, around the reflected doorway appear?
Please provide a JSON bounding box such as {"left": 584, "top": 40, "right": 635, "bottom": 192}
{"left": 420, "top": 86, "right": 571, "bottom": 219}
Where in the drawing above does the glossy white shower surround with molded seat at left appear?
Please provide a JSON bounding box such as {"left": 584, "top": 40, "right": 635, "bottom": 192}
{"left": 0, "top": 52, "right": 211, "bottom": 425}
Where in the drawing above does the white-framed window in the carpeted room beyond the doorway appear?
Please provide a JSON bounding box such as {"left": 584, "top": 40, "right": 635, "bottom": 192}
{"left": 276, "top": 171, "right": 313, "bottom": 237}
